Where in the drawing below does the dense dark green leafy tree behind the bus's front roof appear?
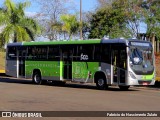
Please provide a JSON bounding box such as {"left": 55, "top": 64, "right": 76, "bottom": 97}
{"left": 89, "top": 2, "right": 130, "bottom": 38}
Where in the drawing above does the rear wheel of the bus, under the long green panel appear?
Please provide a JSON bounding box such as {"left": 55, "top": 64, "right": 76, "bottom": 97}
{"left": 32, "top": 72, "right": 42, "bottom": 85}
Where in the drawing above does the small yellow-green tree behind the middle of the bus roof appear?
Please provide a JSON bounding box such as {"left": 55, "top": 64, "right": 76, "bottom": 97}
{"left": 61, "top": 14, "right": 80, "bottom": 40}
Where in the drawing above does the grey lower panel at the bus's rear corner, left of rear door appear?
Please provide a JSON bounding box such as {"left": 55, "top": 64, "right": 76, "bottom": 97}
{"left": 6, "top": 60, "right": 18, "bottom": 77}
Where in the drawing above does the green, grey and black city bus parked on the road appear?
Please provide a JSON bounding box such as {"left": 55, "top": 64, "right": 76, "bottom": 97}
{"left": 6, "top": 38, "right": 155, "bottom": 90}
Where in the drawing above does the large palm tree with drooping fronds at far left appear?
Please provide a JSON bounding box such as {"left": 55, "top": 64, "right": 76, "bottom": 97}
{"left": 0, "top": 0, "right": 40, "bottom": 43}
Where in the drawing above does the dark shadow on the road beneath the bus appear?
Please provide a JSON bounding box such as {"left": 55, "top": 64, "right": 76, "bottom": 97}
{"left": 0, "top": 77, "right": 140, "bottom": 92}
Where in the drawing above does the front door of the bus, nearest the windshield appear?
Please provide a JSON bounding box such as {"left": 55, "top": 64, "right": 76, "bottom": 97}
{"left": 112, "top": 45, "right": 126, "bottom": 84}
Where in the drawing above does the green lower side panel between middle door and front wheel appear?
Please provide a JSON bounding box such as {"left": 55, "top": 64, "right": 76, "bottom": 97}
{"left": 72, "top": 62, "right": 99, "bottom": 83}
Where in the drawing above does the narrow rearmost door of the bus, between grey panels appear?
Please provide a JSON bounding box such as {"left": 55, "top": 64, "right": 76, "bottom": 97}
{"left": 18, "top": 48, "right": 26, "bottom": 76}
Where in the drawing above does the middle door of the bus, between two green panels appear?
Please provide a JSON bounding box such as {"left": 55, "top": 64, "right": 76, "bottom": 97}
{"left": 62, "top": 48, "right": 73, "bottom": 80}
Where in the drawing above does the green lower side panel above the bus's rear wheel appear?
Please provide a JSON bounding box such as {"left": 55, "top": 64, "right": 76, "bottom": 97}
{"left": 25, "top": 61, "right": 60, "bottom": 80}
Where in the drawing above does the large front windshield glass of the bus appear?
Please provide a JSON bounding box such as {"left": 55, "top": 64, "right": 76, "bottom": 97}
{"left": 129, "top": 47, "right": 154, "bottom": 74}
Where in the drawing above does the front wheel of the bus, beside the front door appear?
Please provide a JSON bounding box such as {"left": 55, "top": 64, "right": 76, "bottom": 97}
{"left": 96, "top": 78, "right": 108, "bottom": 90}
